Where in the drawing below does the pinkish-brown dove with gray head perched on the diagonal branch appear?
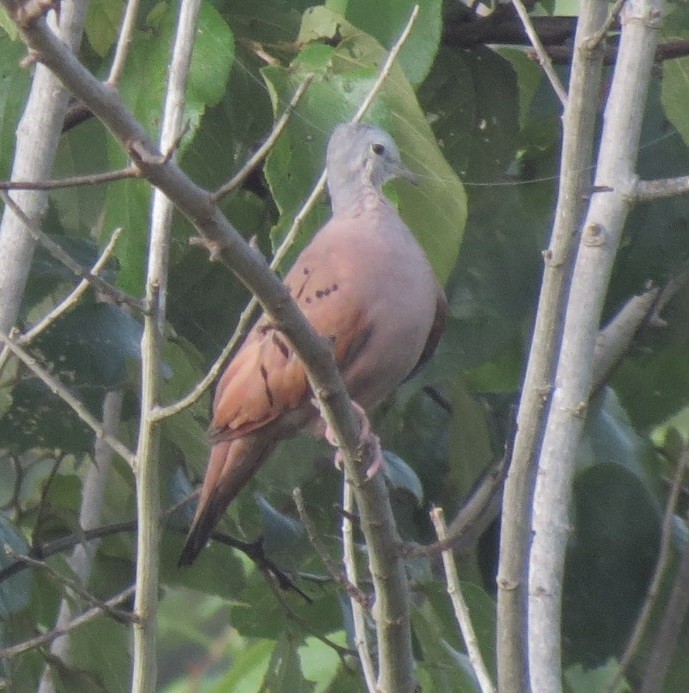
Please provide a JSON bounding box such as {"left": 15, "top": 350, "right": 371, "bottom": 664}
{"left": 179, "top": 124, "right": 446, "bottom": 565}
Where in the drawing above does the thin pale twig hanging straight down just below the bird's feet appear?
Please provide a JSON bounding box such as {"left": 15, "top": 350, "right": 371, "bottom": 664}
{"left": 342, "top": 478, "right": 377, "bottom": 693}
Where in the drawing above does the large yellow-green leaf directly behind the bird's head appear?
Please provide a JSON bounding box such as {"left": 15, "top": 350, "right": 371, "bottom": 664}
{"left": 263, "top": 7, "right": 466, "bottom": 281}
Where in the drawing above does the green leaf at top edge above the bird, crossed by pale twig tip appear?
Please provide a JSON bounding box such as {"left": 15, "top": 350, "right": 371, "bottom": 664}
{"left": 325, "top": 0, "right": 443, "bottom": 85}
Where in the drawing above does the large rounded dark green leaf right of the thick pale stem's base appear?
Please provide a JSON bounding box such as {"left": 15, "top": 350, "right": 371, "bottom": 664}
{"left": 563, "top": 464, "right": 660, "bottom": 666}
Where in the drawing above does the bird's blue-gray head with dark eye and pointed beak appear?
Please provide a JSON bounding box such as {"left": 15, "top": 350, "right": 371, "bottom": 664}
{"left": 327, "top": 123, "right": 416, "bottom": 214}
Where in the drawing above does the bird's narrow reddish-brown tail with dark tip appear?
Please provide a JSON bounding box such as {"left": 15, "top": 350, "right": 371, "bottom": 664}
{"left": 178, "top": 435, "right": 275, "bottom": 567}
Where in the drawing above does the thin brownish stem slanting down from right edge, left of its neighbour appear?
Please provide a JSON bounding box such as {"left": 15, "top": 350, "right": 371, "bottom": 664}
{"left": 607, "top": 441, "right": 689, "bottom": 693}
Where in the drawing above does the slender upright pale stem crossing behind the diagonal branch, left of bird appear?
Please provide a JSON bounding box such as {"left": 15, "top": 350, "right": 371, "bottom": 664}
{"left": 132, "top": 0, "right": 201, "bottom": 693}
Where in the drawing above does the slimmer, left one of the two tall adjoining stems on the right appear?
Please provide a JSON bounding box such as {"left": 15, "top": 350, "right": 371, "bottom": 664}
{"left": 497, "top": 0, "right": 607, "bottom": 693}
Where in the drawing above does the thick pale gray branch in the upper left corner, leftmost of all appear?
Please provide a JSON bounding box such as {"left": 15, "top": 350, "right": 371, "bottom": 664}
{"left": 0, "top": 0, "right": 88, "bottom": 334}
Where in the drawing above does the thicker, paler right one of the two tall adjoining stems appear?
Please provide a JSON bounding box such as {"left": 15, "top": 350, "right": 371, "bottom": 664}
{"left": 528, "top": 0, "right": 663, "bottom": 691}
